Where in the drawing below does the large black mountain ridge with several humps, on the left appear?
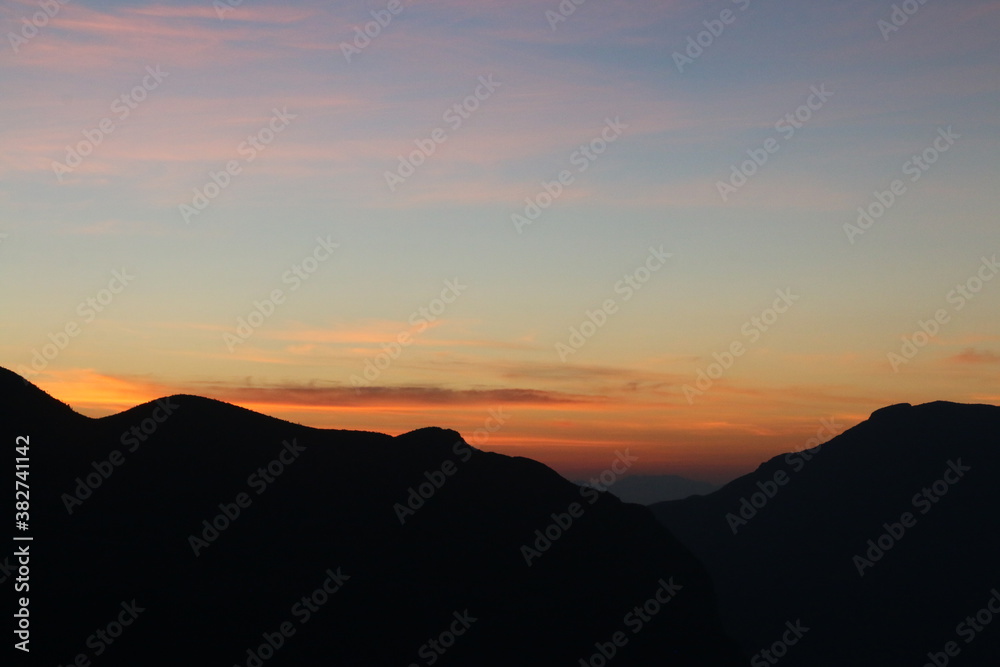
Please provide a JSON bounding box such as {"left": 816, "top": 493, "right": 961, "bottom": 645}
{"left": 0, "top": 370, "right": 745, "bottom": 667}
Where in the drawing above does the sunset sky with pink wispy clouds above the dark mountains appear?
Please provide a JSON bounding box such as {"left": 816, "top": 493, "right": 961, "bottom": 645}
{"left": 0, "top": 0, "right": 1000, "bottom": 483}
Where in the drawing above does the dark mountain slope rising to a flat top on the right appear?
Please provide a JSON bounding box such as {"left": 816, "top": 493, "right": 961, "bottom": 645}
{"left": 652, "top": 402, "right": 1000, "bottom": 667}
